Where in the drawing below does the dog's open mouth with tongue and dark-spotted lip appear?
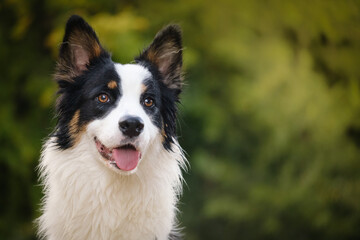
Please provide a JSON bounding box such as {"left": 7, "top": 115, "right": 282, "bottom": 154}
{"left": 94, "top": 138, "right": 141, "bottom": 171}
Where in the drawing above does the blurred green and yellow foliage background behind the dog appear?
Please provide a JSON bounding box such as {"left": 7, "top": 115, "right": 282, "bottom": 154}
{"left": 0, "top": 0, "right": 360, "bottom": 240}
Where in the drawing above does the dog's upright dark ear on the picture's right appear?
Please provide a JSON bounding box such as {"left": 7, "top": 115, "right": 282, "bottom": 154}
{"left": 136, "top": 25, "right": 182, "bottom": 91}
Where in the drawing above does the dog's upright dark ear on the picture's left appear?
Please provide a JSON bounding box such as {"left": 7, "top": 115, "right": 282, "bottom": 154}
{"left": 55, "top": 15, "right": 108, "bottom": 84}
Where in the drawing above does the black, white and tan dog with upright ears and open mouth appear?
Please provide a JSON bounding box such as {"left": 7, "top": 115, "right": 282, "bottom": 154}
{"left": 38, "top": 15, "right": 187, "bottom": 240}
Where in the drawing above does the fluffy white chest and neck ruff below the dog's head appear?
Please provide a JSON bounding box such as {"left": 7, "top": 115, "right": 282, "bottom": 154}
{"left": 38, "top": 134, "right": 186, "bottom": 240}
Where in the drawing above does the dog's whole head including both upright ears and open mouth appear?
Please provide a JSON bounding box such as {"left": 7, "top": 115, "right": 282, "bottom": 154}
{"left": 54, "top": 16, "right": 182, "bottom": 174}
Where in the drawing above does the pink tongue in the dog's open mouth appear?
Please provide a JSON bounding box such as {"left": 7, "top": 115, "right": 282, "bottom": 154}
{"left": 112, "top": 148, "right": 140, "bottom": 171}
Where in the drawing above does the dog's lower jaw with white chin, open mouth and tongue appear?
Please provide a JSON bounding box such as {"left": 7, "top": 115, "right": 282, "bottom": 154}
{"left": 94, "top": 137, "right": 142, "bottom": 175}
